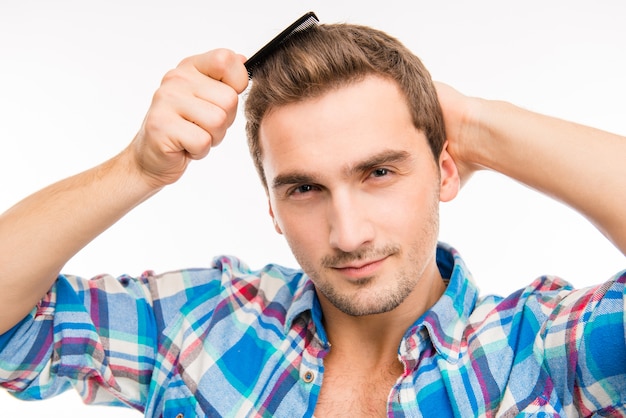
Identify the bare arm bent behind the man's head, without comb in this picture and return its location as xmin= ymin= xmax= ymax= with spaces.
xmin=437 ymin=84 xmax=626 ymax=254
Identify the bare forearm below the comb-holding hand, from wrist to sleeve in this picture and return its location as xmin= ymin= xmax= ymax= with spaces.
xmin=0 ymin=149 xmax=156 ymax=333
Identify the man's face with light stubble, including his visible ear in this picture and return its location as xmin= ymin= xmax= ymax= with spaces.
xmin=260 ymin=76 xmax=458 ymax=316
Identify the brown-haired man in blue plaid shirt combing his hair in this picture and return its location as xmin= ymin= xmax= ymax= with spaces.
xmin=0 ymin=25 xmax=626 ymax=416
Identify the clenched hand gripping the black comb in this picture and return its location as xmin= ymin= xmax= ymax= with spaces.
xmin=127 ymin=49 xmax=248 ymax=188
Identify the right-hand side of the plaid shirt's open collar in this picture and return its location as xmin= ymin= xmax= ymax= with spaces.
xmin=399 ymin=243 xmax=478 ymax=363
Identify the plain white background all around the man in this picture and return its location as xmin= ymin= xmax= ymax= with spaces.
xmin=0 ymin=0 xmax=626 ymax=417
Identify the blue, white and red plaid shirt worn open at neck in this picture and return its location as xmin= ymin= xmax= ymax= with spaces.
xmin=0 ymin=245 xmax=626 ymax=417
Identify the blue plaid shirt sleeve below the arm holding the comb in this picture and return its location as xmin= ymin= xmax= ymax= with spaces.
xmin=0 ymin=269 xmax=213 ymax=410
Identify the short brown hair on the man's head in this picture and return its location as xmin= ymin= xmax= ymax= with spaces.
xmin=245 ymin=24 xmax=445 ymax=188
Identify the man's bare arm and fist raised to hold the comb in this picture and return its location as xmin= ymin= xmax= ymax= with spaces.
xmin=0 ymin=50 xmax=248 ymax=334
